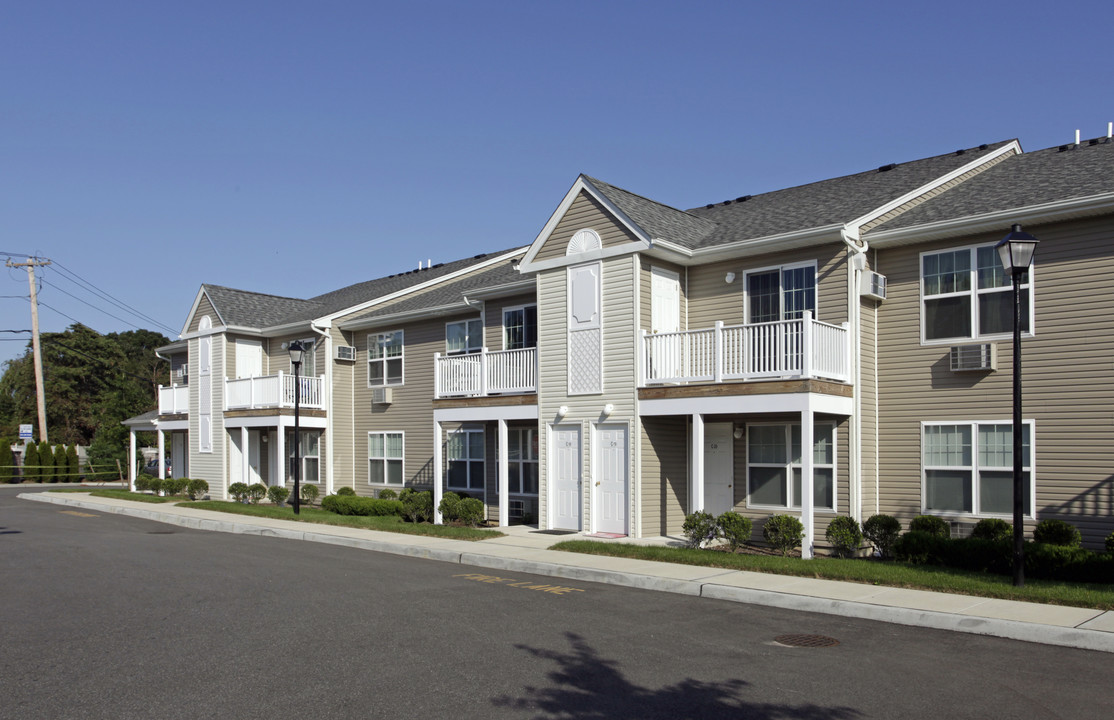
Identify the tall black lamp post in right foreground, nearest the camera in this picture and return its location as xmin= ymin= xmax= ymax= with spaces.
xmin=996 ymin=225 xmax=1037 ymax=587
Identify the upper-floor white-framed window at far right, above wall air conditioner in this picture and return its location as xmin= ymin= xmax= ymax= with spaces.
xmin=920 ymin=245 xmax=1033 ymax=341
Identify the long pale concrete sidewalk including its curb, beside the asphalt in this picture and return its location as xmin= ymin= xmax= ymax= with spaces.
xmin=19 ymin=493 xmax=1114 ymax=652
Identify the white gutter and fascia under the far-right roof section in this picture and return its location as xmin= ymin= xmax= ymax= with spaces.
xmin=868 ymin=193 xmax=1114 ymax=247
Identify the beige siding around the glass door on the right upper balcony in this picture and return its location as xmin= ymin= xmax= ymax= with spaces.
xmin=686 ymin=243 xmax=848 ymax=330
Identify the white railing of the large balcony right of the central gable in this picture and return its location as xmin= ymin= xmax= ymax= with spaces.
xmin=642 ymin=312 xmax=851 ymax=386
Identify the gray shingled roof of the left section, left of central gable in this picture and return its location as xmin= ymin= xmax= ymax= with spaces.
xmin=202 ymin=249 xmax=525 ymax=328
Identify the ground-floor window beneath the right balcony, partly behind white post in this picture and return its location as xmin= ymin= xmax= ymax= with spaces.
xmin=746 ymin=422 xmax=836 ymax=510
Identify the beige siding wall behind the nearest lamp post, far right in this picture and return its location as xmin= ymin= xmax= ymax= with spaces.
xmin=878 ymin=218 xmax=1114 ymax=546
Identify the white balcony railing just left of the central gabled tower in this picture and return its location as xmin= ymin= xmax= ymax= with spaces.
xmin=433 ymin=348 xmax=538 ymax=398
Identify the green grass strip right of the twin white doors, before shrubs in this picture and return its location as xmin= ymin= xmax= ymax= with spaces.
xmin=553 ymin=541 xmax=1114 ymax=610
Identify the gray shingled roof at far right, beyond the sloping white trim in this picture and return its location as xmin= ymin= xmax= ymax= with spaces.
xmin=871 ymin=137 xmax=1114 ymax=232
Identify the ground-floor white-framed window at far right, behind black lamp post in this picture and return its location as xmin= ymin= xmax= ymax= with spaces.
xmin=921 ymin=420 xmax=1034 ymax=517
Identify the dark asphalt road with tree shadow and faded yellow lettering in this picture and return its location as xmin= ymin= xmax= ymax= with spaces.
xmin=0 ymin=488 xmax=1114 ymax=720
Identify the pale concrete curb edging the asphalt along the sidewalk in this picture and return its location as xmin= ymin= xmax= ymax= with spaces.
xmin=26 ymin=493 xmax=1114 ymax=653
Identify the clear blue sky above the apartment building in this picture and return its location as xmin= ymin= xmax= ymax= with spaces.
xmin=0 ymin=0 xmax=1114 ymax=367
